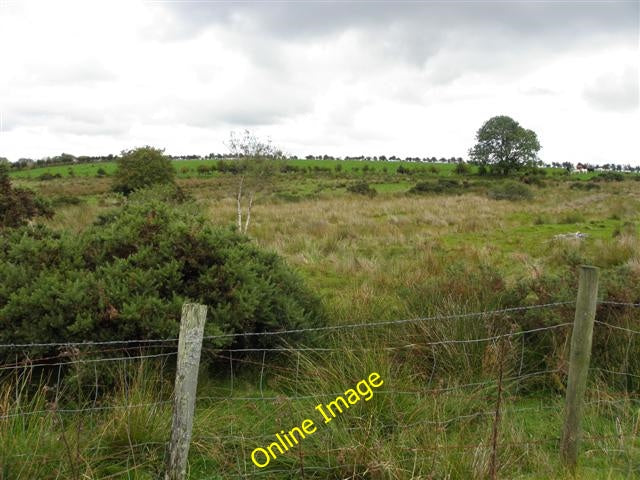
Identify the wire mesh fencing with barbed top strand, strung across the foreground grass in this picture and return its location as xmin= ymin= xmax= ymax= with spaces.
xmin=0 ymin=301 xmax=640 ymax=480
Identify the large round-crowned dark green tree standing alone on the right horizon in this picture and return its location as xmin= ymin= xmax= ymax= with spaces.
xmin=469 ymin=115 xmax=540 ymax=175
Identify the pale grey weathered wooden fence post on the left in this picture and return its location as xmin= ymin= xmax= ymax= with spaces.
xmin=165 ymin=303 xmax=207 ymax=480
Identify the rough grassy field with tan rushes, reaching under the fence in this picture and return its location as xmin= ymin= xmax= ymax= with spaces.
xmin=0 ymin=160 xmax=640 ymax=480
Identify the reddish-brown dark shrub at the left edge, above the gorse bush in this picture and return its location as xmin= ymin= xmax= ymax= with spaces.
xmin=0 ymin=164 xmax=53 ymax=231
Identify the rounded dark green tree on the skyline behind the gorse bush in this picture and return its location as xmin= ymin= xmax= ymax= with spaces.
xmin=113 ymin=146 xmax=176 ymax=195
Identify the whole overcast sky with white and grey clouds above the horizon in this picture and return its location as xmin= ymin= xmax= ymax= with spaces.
xmin=0 ymin=0 xmax=640 ymax=165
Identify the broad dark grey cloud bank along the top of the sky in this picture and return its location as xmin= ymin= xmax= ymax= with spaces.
xmin=157 ymin=1 xmax=638 ymax=85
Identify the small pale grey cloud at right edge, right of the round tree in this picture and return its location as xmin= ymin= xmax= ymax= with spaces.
xmin=583 ymin=67 xmax=640 ymax=112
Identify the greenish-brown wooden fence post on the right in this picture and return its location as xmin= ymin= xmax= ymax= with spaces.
xmin=560 ymin=265 xmax=598 ymax=470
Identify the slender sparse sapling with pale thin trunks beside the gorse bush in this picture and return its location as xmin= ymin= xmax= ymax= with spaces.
xmin=227 ymin=130 xmax=283 ymax=235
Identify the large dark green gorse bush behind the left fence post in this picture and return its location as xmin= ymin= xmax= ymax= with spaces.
xmin=0 ymin=192 xmax=324 ymax=364
